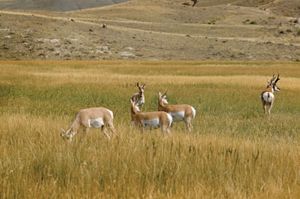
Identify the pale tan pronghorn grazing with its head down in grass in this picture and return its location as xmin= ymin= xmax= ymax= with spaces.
xmin=61 ymin=107 xmax=115 ymax=140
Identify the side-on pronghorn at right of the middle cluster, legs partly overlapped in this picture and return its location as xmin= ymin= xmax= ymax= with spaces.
xmin=158 ymin=92 xmax=196 ymax=131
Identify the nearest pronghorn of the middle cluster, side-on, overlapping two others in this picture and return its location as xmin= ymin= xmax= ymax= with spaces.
xmin=130 ymin=99 xmax=173 ymax=134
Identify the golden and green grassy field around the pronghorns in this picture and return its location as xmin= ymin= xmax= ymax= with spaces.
xmin=0 ymin=61 xmax=300 ymax=198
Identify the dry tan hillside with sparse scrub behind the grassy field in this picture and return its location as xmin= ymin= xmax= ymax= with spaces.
xmin=0 ymin=0 xmax=300 ymax=61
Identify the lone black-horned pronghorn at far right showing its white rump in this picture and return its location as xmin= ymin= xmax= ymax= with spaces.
xmin=260 ymin=74 xmax=280 ymax=114
